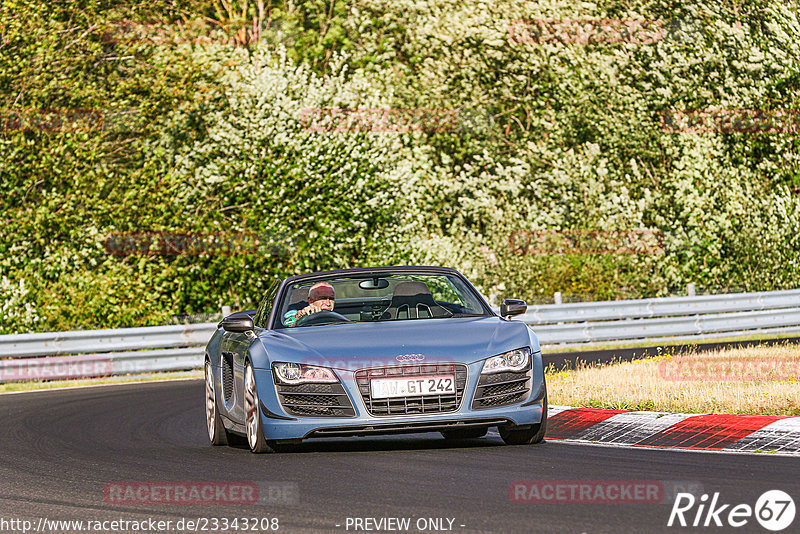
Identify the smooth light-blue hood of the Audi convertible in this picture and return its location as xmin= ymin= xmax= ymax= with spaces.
xmin=261 ymin=317 xmax=539 ymax=370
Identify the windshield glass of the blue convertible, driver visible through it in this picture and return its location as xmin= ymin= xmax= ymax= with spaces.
xmin=275 ymin=273 xmax=490 ymax=328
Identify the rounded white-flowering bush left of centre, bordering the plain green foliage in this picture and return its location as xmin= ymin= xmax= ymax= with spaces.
xmin=175 ymin=47 xmax=432 ymax=286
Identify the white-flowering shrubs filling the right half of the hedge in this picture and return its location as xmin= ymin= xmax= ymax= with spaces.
xmin=340 ymin=0 xmax=800 ymax=298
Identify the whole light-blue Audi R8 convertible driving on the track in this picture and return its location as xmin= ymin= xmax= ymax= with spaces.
xmin=205 ymin=267 xmax=547 ymax=453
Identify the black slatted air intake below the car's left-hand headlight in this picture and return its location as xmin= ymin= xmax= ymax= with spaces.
xmin=275 ymin=383 xmax=356 ymax=417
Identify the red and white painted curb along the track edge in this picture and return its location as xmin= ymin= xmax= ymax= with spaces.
xmin=494 ymin=406 xmax=800 ymax=456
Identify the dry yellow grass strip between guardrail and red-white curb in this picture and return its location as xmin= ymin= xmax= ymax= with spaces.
xmin=547 ymin=345 xmax=800 ymax=416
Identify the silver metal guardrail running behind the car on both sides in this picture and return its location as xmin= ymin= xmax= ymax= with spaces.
xmin=0 ymin=290 xmax=800 ymax=383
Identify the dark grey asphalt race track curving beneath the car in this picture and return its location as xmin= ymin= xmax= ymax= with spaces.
xmin=0 ymin=380 xmax=800 ymax=534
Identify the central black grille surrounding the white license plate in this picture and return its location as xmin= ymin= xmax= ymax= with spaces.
xmin=355 ymin=363 xmax=467 ymax=415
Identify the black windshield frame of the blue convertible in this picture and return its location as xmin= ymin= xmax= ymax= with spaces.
xmin=267 ymin=266 xmax=497 ymax=332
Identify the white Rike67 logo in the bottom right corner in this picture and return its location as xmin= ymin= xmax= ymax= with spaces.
xmin=667 ymin=490 xmax=796 ymax=532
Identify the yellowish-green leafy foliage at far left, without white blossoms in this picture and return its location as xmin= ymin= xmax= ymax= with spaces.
xmin=0 ymin=1 xmax=232 ymax=331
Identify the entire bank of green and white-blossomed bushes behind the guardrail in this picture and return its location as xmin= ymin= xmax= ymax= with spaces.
xmin=0 ymin=0 xmax=800 ymax=332
